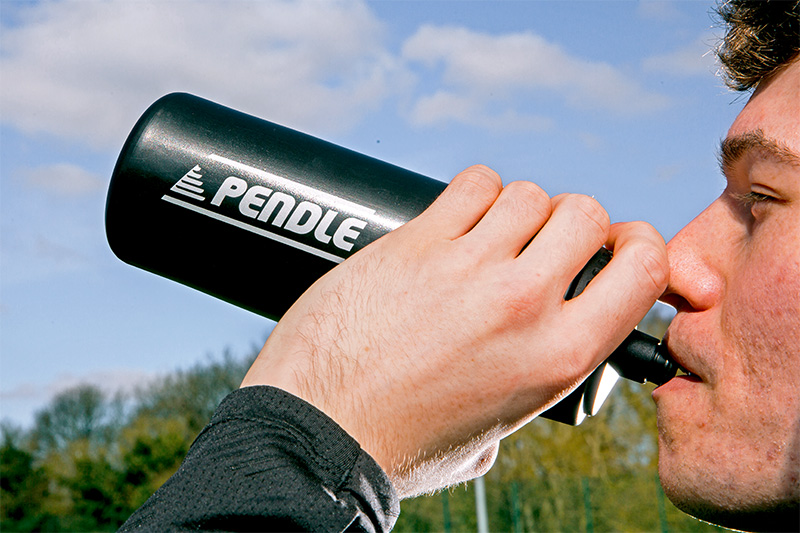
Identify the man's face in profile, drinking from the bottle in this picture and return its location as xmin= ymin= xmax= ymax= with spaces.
xmin=653 ymin=60 xmax=800 ymax=530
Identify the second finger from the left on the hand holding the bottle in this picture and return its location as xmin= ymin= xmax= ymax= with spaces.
xmin=462 ymin=181 xmax=552 ymax=259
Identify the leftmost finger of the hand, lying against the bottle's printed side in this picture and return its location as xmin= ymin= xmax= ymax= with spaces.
xmin=406 ymin=165 xmax=503 ymax=239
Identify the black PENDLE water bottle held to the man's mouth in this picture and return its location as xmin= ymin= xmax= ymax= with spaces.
xmin=106 ymin=93 xmax=675 ymax=424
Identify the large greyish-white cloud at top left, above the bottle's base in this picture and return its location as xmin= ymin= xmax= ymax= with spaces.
xmin=0 ymin=0 xmax=402 ymax=147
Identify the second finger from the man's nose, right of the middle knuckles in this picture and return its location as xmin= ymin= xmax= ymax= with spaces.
xmin=520 ymin=194 xmax=610 ymax=288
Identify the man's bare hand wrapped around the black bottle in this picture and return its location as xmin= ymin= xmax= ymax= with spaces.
xmin=242 ymin=166 xmax=668 ymax=497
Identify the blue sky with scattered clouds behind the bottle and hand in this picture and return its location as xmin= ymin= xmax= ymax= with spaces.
xmin=0 ymin=0 xmax=745 ymax=424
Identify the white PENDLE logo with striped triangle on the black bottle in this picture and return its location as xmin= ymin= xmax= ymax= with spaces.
xmin=161 ymin=154 xmax=375 ymax=263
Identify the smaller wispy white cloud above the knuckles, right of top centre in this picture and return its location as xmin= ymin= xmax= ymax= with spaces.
xmin=402 ymin=25 xmax=669 ymax=128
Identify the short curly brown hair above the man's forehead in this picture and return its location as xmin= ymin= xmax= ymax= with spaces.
xmin=717 ymin=0 xmax=800 ymax=91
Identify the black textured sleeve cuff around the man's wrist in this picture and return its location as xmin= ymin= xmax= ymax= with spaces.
xmin=120 ymin=387 xmax=400 ymax=531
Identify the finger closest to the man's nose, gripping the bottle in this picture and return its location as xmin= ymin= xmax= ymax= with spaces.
xmin=564 ymin=222 xmax=669 ymax=365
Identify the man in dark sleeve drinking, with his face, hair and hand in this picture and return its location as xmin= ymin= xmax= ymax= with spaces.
xmin=123 ymin=1 xmax=800 ymax=530
